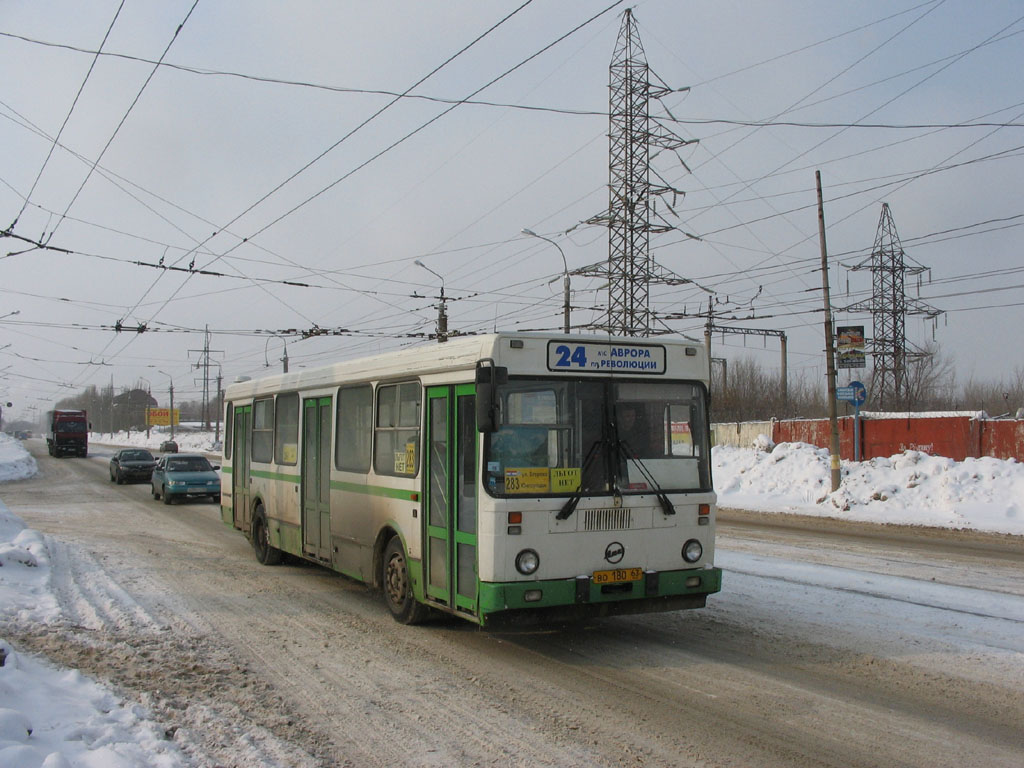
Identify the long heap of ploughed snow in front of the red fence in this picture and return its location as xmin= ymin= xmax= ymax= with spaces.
xmin=712 ymin=442 xmax=1024 ymax=536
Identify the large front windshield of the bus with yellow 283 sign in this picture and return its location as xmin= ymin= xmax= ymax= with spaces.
xmin=483 ymin=378 xmax=711 ymax=496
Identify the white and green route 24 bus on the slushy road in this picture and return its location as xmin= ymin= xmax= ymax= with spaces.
xmin=221 ymin=333 xmax=722 ymax=627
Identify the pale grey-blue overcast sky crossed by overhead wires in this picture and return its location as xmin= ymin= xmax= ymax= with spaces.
xmin=0 ymin=0 xmax=1024 ymax=417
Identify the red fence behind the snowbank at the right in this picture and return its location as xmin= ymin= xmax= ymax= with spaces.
xmin=772 ymin=414 xmax=1024 ymax=461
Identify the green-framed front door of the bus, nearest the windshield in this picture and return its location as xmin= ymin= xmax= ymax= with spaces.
xmin=423 ymin=384 xmax=478 ymax=614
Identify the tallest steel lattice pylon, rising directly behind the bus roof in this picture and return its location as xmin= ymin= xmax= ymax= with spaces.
xmin=579 ymin=9 xmax=693 ymax=336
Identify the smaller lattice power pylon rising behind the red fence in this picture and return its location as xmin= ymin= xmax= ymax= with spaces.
xmin=848 ymin=203 xmax=941 ymax=410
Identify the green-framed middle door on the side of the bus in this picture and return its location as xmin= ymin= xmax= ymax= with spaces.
xmin=301 ymin=397 xmax=331 ymax=562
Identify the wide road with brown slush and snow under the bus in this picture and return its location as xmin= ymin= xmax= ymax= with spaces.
xmin=0 ymin=444 xmax=1024 ymax=768
